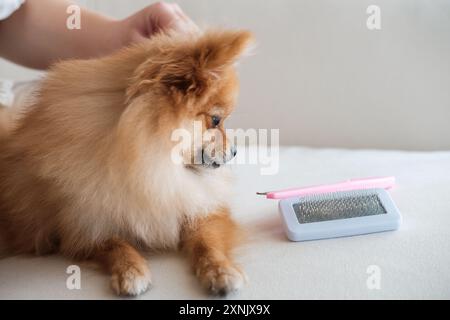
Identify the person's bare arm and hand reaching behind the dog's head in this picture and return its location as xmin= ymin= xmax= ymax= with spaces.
xmin=0 ymin=0 xmax=194 ymax=69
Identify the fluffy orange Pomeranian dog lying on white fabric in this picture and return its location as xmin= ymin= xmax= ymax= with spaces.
xmin=0 ymin=30 xmax=252 ymax=295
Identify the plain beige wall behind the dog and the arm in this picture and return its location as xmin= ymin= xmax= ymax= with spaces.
xmin=0 ymin=0 xmax=450 ymax=150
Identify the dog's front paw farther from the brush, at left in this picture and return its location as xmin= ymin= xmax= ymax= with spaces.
xmin=111 ymin=266 xmax=152 ymax=296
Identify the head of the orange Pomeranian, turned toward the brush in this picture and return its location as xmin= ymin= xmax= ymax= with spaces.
xmin=127 ymin=31 xmax=252 ymax=168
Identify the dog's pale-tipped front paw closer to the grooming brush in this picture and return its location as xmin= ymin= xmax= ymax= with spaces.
xmin=197 ymin=264 xmax=247 ymax=296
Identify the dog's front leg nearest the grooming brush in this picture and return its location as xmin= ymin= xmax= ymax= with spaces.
xmin=182 ymin=209 xmax=246 ymax=295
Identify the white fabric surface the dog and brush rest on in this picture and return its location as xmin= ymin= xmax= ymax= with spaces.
xmin=0 ymin=147 xmax=450 ymax=299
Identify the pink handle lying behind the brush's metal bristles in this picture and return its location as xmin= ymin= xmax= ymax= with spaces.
xmin=266 ymin=177 xmax=395 ymax=199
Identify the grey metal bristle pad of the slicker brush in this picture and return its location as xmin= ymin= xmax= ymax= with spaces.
xmin=294 ymin=190 xmax=386 ymax=223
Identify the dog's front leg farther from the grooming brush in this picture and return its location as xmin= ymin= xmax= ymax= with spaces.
xmin=93 ymin=239 xmax=151 ymax=296
